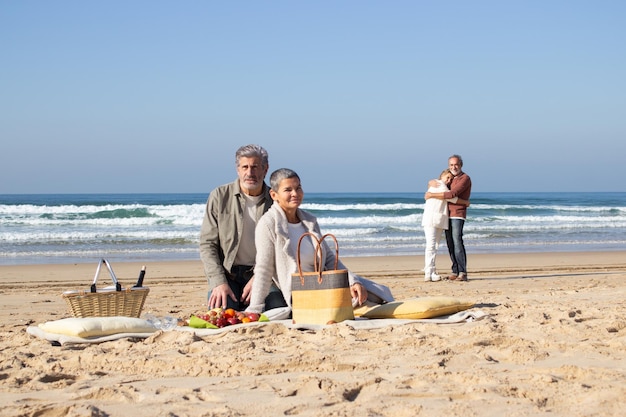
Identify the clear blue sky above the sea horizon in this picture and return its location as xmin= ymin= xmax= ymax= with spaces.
xmin=0 ymin=0 xmax=626 ymax=194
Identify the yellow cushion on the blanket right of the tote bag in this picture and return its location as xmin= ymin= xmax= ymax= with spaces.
xmin=355 ymin=296 xmax=474 ymax=319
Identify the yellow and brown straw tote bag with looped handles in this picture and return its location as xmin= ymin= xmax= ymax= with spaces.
xmin=291 ymin=232 xmax=354 ymax=324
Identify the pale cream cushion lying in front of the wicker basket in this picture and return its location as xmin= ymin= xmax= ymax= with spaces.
xmin=39 ymin=317 xmax=157 ymax=337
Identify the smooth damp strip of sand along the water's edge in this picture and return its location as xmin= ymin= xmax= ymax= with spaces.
xmin=0 ymin=251 xmax=626 ymax=286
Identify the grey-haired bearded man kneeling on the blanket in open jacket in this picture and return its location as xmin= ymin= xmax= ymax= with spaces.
xmin=200 ymin=144 xmax=286 ymax=311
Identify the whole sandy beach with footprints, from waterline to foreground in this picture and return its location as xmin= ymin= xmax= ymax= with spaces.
xmin=0 ymin=252 xmax=626 ymax=417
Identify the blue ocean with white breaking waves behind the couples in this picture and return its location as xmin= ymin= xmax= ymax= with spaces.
xmin=0 ymin=192 xmax=626 ymax=265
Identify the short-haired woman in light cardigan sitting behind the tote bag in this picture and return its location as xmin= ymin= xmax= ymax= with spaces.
xmin=246 ymin=168 xmax=368 ymax=313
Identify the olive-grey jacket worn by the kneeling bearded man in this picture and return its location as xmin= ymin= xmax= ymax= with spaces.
xmin=200 ymin=179 xmax=273 ymax=290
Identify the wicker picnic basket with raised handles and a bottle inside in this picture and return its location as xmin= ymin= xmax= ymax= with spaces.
xmin=63 ymin=259 xmax=150 ymax=317
